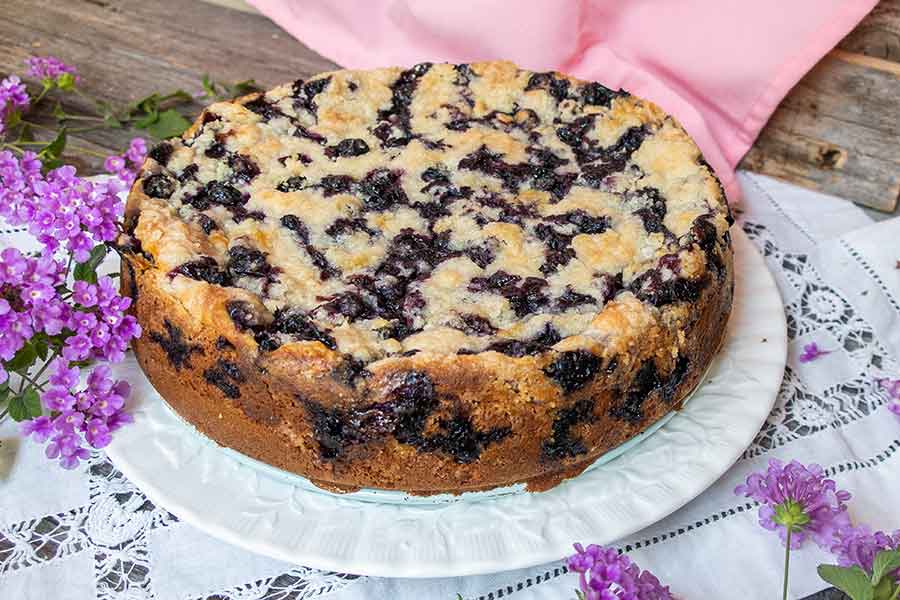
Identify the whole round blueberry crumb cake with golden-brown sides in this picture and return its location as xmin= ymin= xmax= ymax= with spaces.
xmin=120 ymin=62 xmax=733 ymax=494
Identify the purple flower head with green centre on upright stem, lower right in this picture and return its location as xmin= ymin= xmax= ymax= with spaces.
xmin=734 ymin=458 xmax=850 ymax=548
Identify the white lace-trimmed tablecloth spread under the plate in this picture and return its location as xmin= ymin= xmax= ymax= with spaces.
xmin=0 ymin=174 xmax=900 ymax=600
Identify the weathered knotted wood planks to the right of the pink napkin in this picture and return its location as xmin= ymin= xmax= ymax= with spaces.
xmin=741 ymin=0 xmax=900 ymax=212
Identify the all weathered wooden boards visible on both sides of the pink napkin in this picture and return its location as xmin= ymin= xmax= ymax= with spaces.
xmin=0 ymin=0 xmax=900 ymax=212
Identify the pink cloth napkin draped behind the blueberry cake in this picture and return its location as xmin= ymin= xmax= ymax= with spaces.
xmin=249 ymin=0 xmax=877 ymax=199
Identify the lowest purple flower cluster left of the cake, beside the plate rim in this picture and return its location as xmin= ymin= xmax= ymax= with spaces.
xmin=20 ymin=358 xmax=132 ymax=469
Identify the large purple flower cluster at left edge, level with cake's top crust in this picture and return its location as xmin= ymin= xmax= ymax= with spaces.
xmin=0 ymin=151 xmax=129 ymax=262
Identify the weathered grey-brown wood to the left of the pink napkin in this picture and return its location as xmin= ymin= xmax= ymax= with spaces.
xmin=0 ymin=0 xmax=335 ymax=172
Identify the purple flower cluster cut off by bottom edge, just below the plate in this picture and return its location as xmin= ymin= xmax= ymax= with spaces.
xmin=566 ymin=544 xmax=672 ymax=600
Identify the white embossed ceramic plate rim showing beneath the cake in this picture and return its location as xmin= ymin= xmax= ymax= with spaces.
xmin=107 ymin=228 xmax=787 ymax=577
